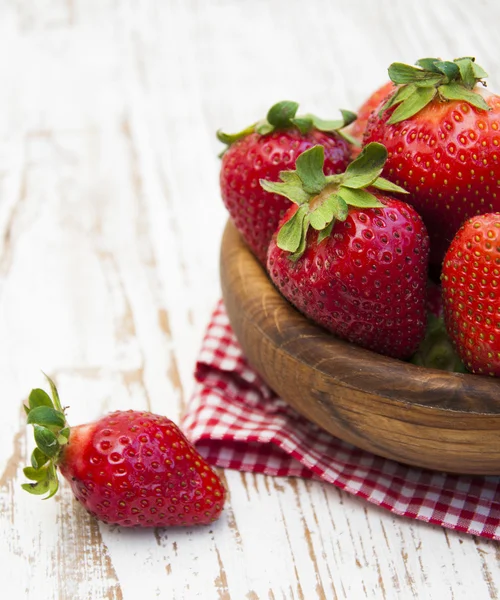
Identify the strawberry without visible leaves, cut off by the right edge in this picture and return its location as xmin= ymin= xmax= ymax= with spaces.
xmin=442 ymin=213 xmax=500 ymax=377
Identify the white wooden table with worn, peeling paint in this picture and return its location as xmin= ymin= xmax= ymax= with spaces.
xmin=0 ymin=0 xmax=500 ymax=600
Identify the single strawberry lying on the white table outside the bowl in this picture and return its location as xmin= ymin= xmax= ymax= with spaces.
xmin=23 ymin=379 xmax=225 ymax=527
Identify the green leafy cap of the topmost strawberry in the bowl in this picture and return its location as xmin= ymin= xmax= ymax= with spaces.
xmin=379 ymin=56 xmax=491 ymax=125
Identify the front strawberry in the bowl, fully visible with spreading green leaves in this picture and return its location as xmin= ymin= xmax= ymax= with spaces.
xmin=262 ymin=144 xmax=429 ymax=359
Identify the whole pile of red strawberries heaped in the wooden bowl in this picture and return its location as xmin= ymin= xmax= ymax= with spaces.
xmin=218 ymin=57 xmax=500 ymax=376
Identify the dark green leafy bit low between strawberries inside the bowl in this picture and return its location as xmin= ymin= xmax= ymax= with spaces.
xmin=410 ymin=313 xmax=467 ymax=373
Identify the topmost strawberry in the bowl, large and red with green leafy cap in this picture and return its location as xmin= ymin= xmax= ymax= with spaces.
xmin=364 ymin=58 xmax=500 ymax=271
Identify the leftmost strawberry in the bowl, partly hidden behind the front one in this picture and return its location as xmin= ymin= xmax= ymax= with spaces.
xmin=217 ymin=101 xmax=356 ymax=264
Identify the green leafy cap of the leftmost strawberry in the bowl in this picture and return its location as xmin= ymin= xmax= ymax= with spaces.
xmin=217 ymin=100 xmax=359 ymax=147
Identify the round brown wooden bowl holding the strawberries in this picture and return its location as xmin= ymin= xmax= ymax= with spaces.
xmin=221 ymin=223 xmax=500 ymax=475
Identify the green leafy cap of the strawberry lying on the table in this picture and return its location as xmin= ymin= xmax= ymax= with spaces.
xmin=22 ymin=375 xmax=70 ymax=499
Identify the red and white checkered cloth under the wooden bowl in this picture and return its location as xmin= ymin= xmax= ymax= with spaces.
xmin=182 ymin=302 xmax=500 ymax=540
